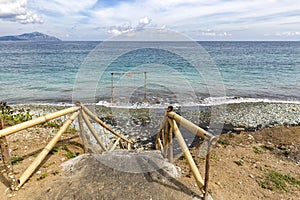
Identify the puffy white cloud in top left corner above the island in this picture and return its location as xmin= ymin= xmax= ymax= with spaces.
xmin=0 ymin=0 xmax=43 ymax=24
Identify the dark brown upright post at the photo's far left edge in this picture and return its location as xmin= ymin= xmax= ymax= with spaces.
xmin=0 ymin=119 xmax=17 ymax=190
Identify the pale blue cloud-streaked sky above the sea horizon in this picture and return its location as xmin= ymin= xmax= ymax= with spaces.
xmin=0 ymin=0 xmax=300 ymax=41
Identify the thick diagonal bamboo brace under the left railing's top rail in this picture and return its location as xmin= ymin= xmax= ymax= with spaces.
xmin=17 ymin=112 xmax=79 ymax=189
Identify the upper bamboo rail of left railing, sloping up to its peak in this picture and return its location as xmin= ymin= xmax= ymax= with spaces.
xmin=0 ymin=107 xmax=80 ymax=137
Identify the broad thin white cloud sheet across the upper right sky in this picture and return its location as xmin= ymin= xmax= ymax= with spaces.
xmin=93 ymin=0 xmax=300 ymax=35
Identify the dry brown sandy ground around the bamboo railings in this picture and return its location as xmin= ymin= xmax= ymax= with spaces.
xmin=0 ymin=127 xmax=300 ymax=200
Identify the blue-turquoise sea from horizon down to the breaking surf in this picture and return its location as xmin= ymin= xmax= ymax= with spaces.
xmin=0 ymin=41 xmax=300 ymax=107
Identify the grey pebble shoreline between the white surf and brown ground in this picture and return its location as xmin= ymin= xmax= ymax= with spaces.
xmin=11 ymin=102 xmax=300 ymax=134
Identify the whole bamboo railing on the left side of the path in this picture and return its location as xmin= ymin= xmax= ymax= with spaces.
xmin=0 ymin=103 xmax=132 ymax=190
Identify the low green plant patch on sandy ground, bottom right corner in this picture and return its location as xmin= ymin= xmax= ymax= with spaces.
xmin=259 ymin=171 xmax=300 ymax=192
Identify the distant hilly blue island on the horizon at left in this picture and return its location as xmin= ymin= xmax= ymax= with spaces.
xmin=0 ymin=32 xmax=61 ymax=42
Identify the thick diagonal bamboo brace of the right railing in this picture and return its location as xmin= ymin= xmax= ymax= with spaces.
xmin=168 ymin=119 xmax=204 ymax=193
